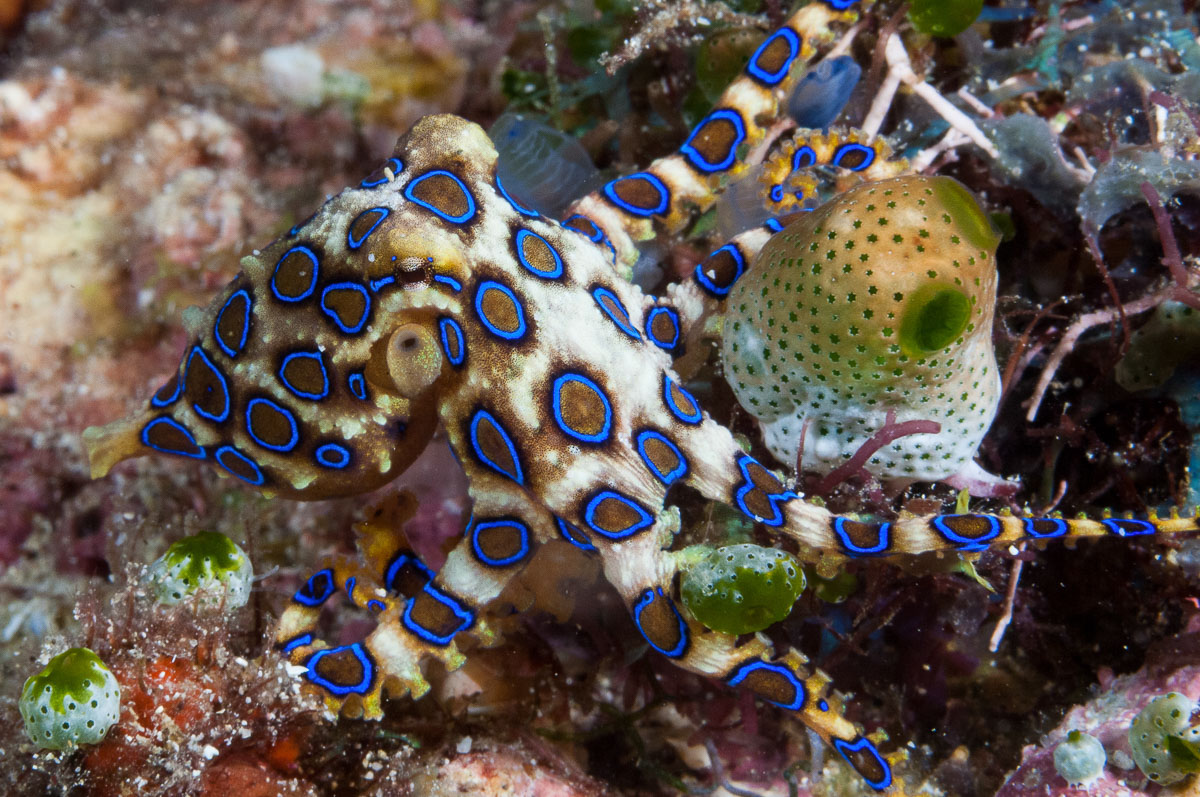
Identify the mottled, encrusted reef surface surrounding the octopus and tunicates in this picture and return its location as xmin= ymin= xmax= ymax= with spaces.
xmin=0 ymin=0 xmax=1200 ymax=797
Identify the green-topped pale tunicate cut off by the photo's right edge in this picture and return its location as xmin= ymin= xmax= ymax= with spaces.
xmin=1129 ymin=691 xmax=1200 ymax=786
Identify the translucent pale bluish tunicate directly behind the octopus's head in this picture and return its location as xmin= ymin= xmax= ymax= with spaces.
xmin=487 ymin=113 xmax=600 ymax=217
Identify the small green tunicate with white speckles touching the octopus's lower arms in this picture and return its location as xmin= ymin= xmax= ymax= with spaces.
xmin=680 ymin=543 xmax=804 ymax=635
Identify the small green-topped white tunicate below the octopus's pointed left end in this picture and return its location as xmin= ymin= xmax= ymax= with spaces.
xmin=146 ymin=532 xmax=254 ymax=609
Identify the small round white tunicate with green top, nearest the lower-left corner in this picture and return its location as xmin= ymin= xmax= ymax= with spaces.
xmin=19 ymin=648 xmax=121 ymax=750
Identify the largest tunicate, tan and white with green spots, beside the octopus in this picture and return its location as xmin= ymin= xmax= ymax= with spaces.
xmin=722 ymin=176 xmax=1001 ymax=481
